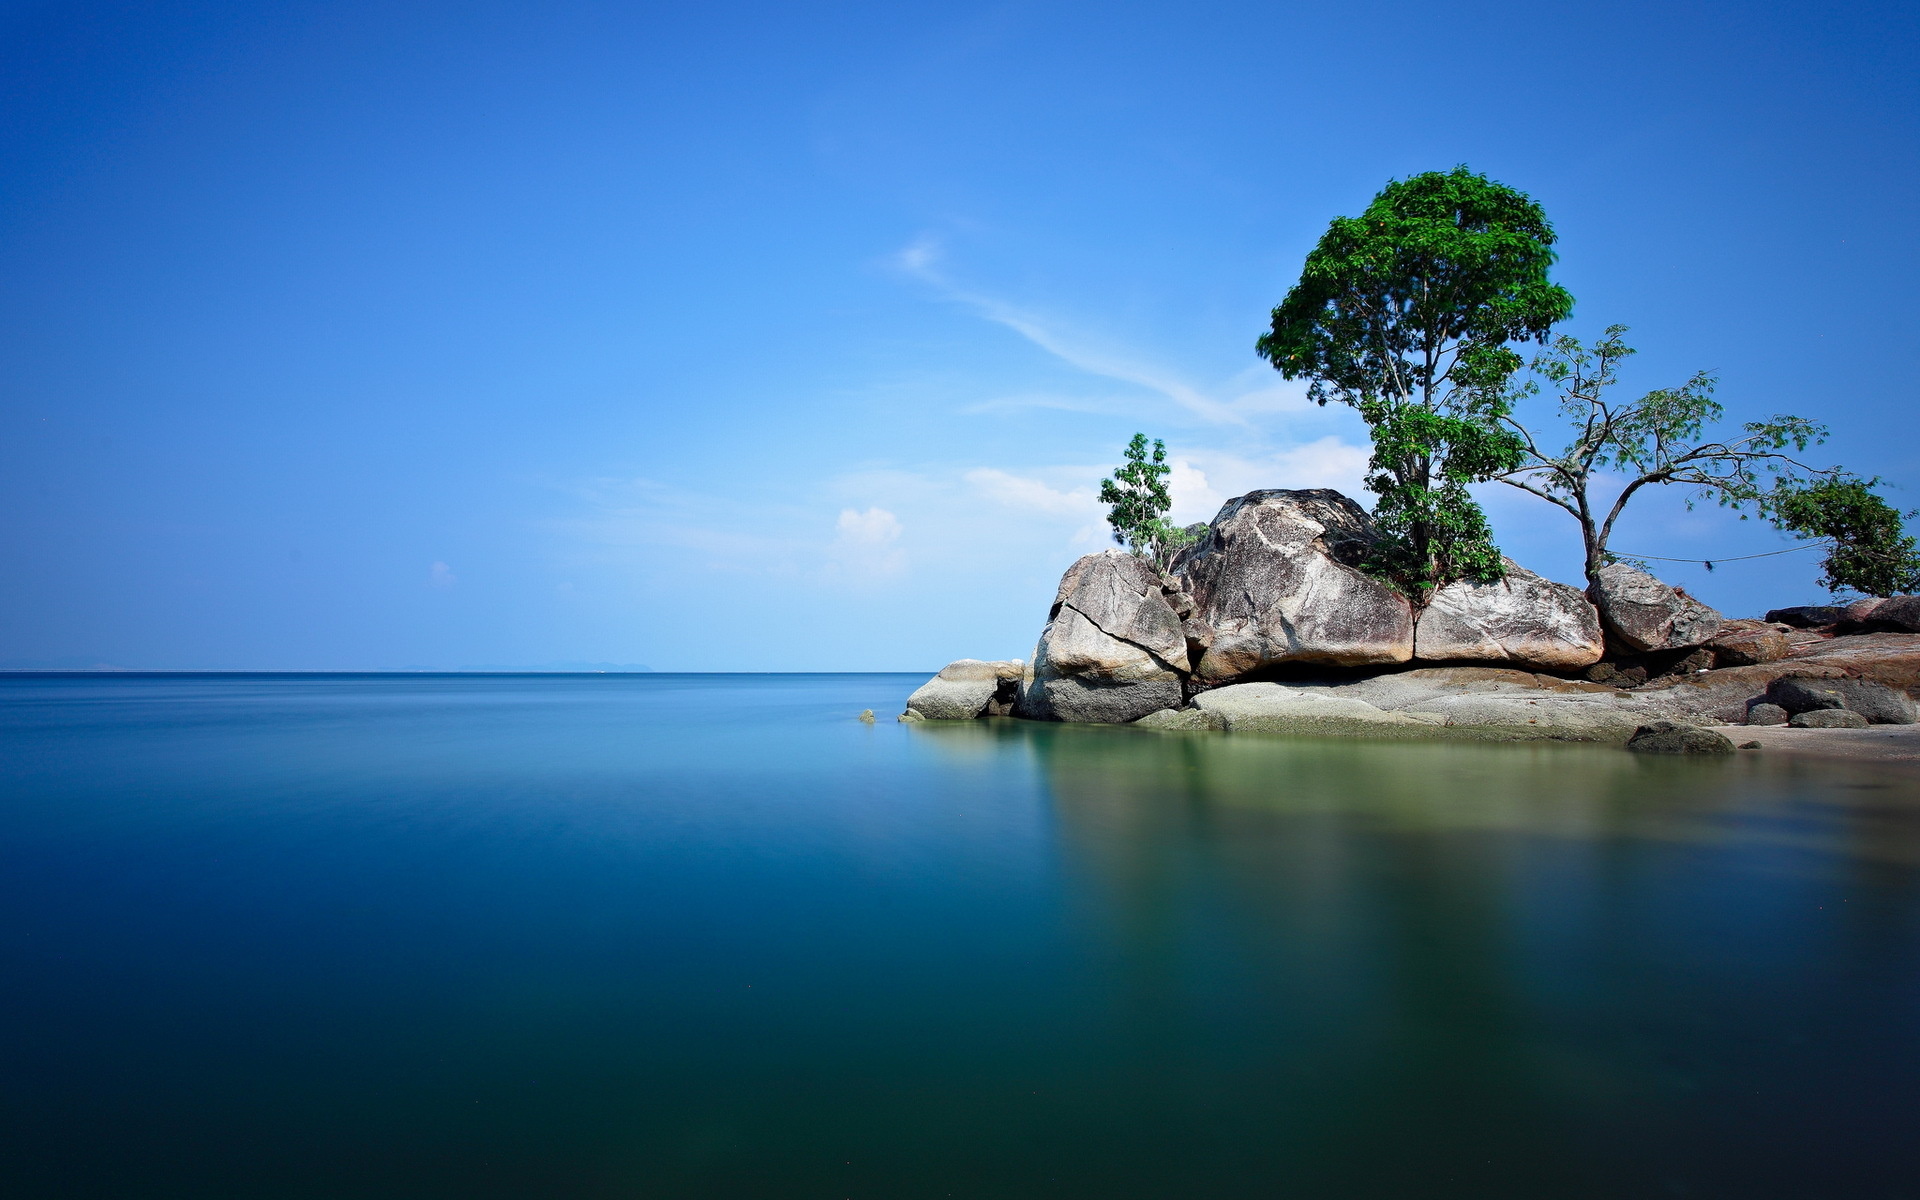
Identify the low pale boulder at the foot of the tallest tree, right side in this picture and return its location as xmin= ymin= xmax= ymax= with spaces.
xmin=1413 ymin=559 xmax=1607 ymax=670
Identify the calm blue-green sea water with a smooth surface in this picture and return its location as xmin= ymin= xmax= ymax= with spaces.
xmin=0 ymin=676 xmax=1920 ymax=1200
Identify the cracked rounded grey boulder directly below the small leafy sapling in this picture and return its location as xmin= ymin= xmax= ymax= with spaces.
xmin=1016 ymin=549 xmax=1188 ymax=724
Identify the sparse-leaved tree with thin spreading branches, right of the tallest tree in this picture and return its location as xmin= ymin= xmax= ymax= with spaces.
xmin=1494 ymin=324 xmax=1834 ymax=582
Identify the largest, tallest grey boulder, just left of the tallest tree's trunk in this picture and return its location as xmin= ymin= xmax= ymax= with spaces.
xmin=1175 ymin=488 xmax=1413 ymax=684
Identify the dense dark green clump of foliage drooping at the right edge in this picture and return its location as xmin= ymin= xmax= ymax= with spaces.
xmin=1764 ymin=472 xmax=1920 ymax=595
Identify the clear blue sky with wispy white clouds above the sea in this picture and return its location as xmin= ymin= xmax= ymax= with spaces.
xmin=0 ymin=0 xmax=1920 ymax=670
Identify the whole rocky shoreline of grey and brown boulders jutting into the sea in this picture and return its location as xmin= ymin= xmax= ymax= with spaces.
xmin=900 ymin=490 xmax=1920 ymax=751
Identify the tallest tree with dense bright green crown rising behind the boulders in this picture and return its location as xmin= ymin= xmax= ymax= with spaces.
xmin=1256 ymin=167 xmax=1572 ymax=593
